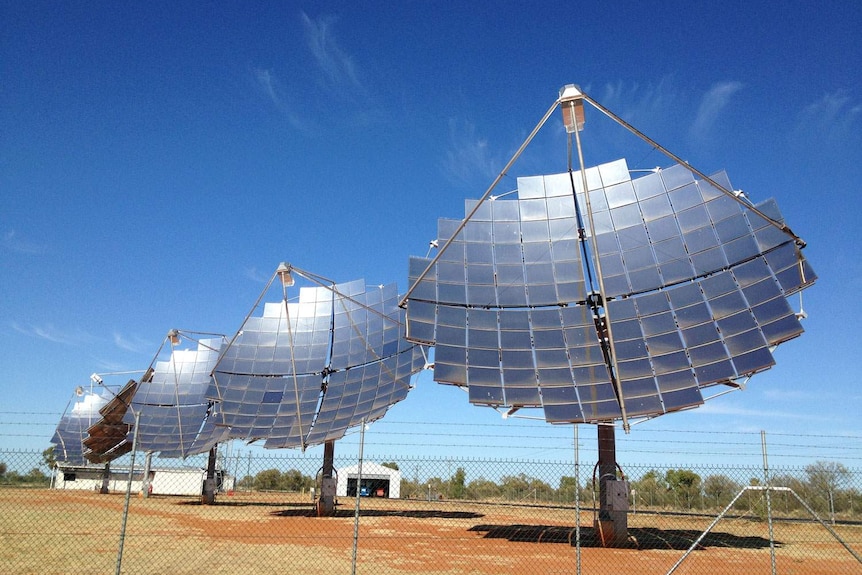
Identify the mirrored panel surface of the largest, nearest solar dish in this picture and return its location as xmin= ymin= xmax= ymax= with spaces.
xmin=406 ymin=156 xmax=815 ymax=423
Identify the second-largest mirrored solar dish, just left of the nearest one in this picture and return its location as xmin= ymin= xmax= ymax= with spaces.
xmin=207 ymin=264 xmax=426 ymax=449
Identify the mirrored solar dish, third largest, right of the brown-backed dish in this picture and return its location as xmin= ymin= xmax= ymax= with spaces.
xmin=123 ymin=330 xmax=228 ymax=458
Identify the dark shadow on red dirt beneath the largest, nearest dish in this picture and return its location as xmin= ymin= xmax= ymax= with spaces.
xmin=470 ymin=525 xmax=781 ymax=551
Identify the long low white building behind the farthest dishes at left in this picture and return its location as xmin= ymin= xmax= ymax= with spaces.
xmin=53 ymin=463 xmax=234 ymax=496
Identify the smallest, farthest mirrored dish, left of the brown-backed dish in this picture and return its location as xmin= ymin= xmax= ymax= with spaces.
xmin=51 ymin=387 xmax=114 ymax=465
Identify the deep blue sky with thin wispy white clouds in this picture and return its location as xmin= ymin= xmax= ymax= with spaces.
xmin=0 ymin=0 xmax=862 ymax=465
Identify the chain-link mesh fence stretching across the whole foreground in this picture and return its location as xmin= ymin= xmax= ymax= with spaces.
xmin=0 ymin=434 xmax=862 ymax=575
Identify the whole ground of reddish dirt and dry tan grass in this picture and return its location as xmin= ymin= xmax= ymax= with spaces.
xmin=0 ymin=489 xmax=862 ymax=575
